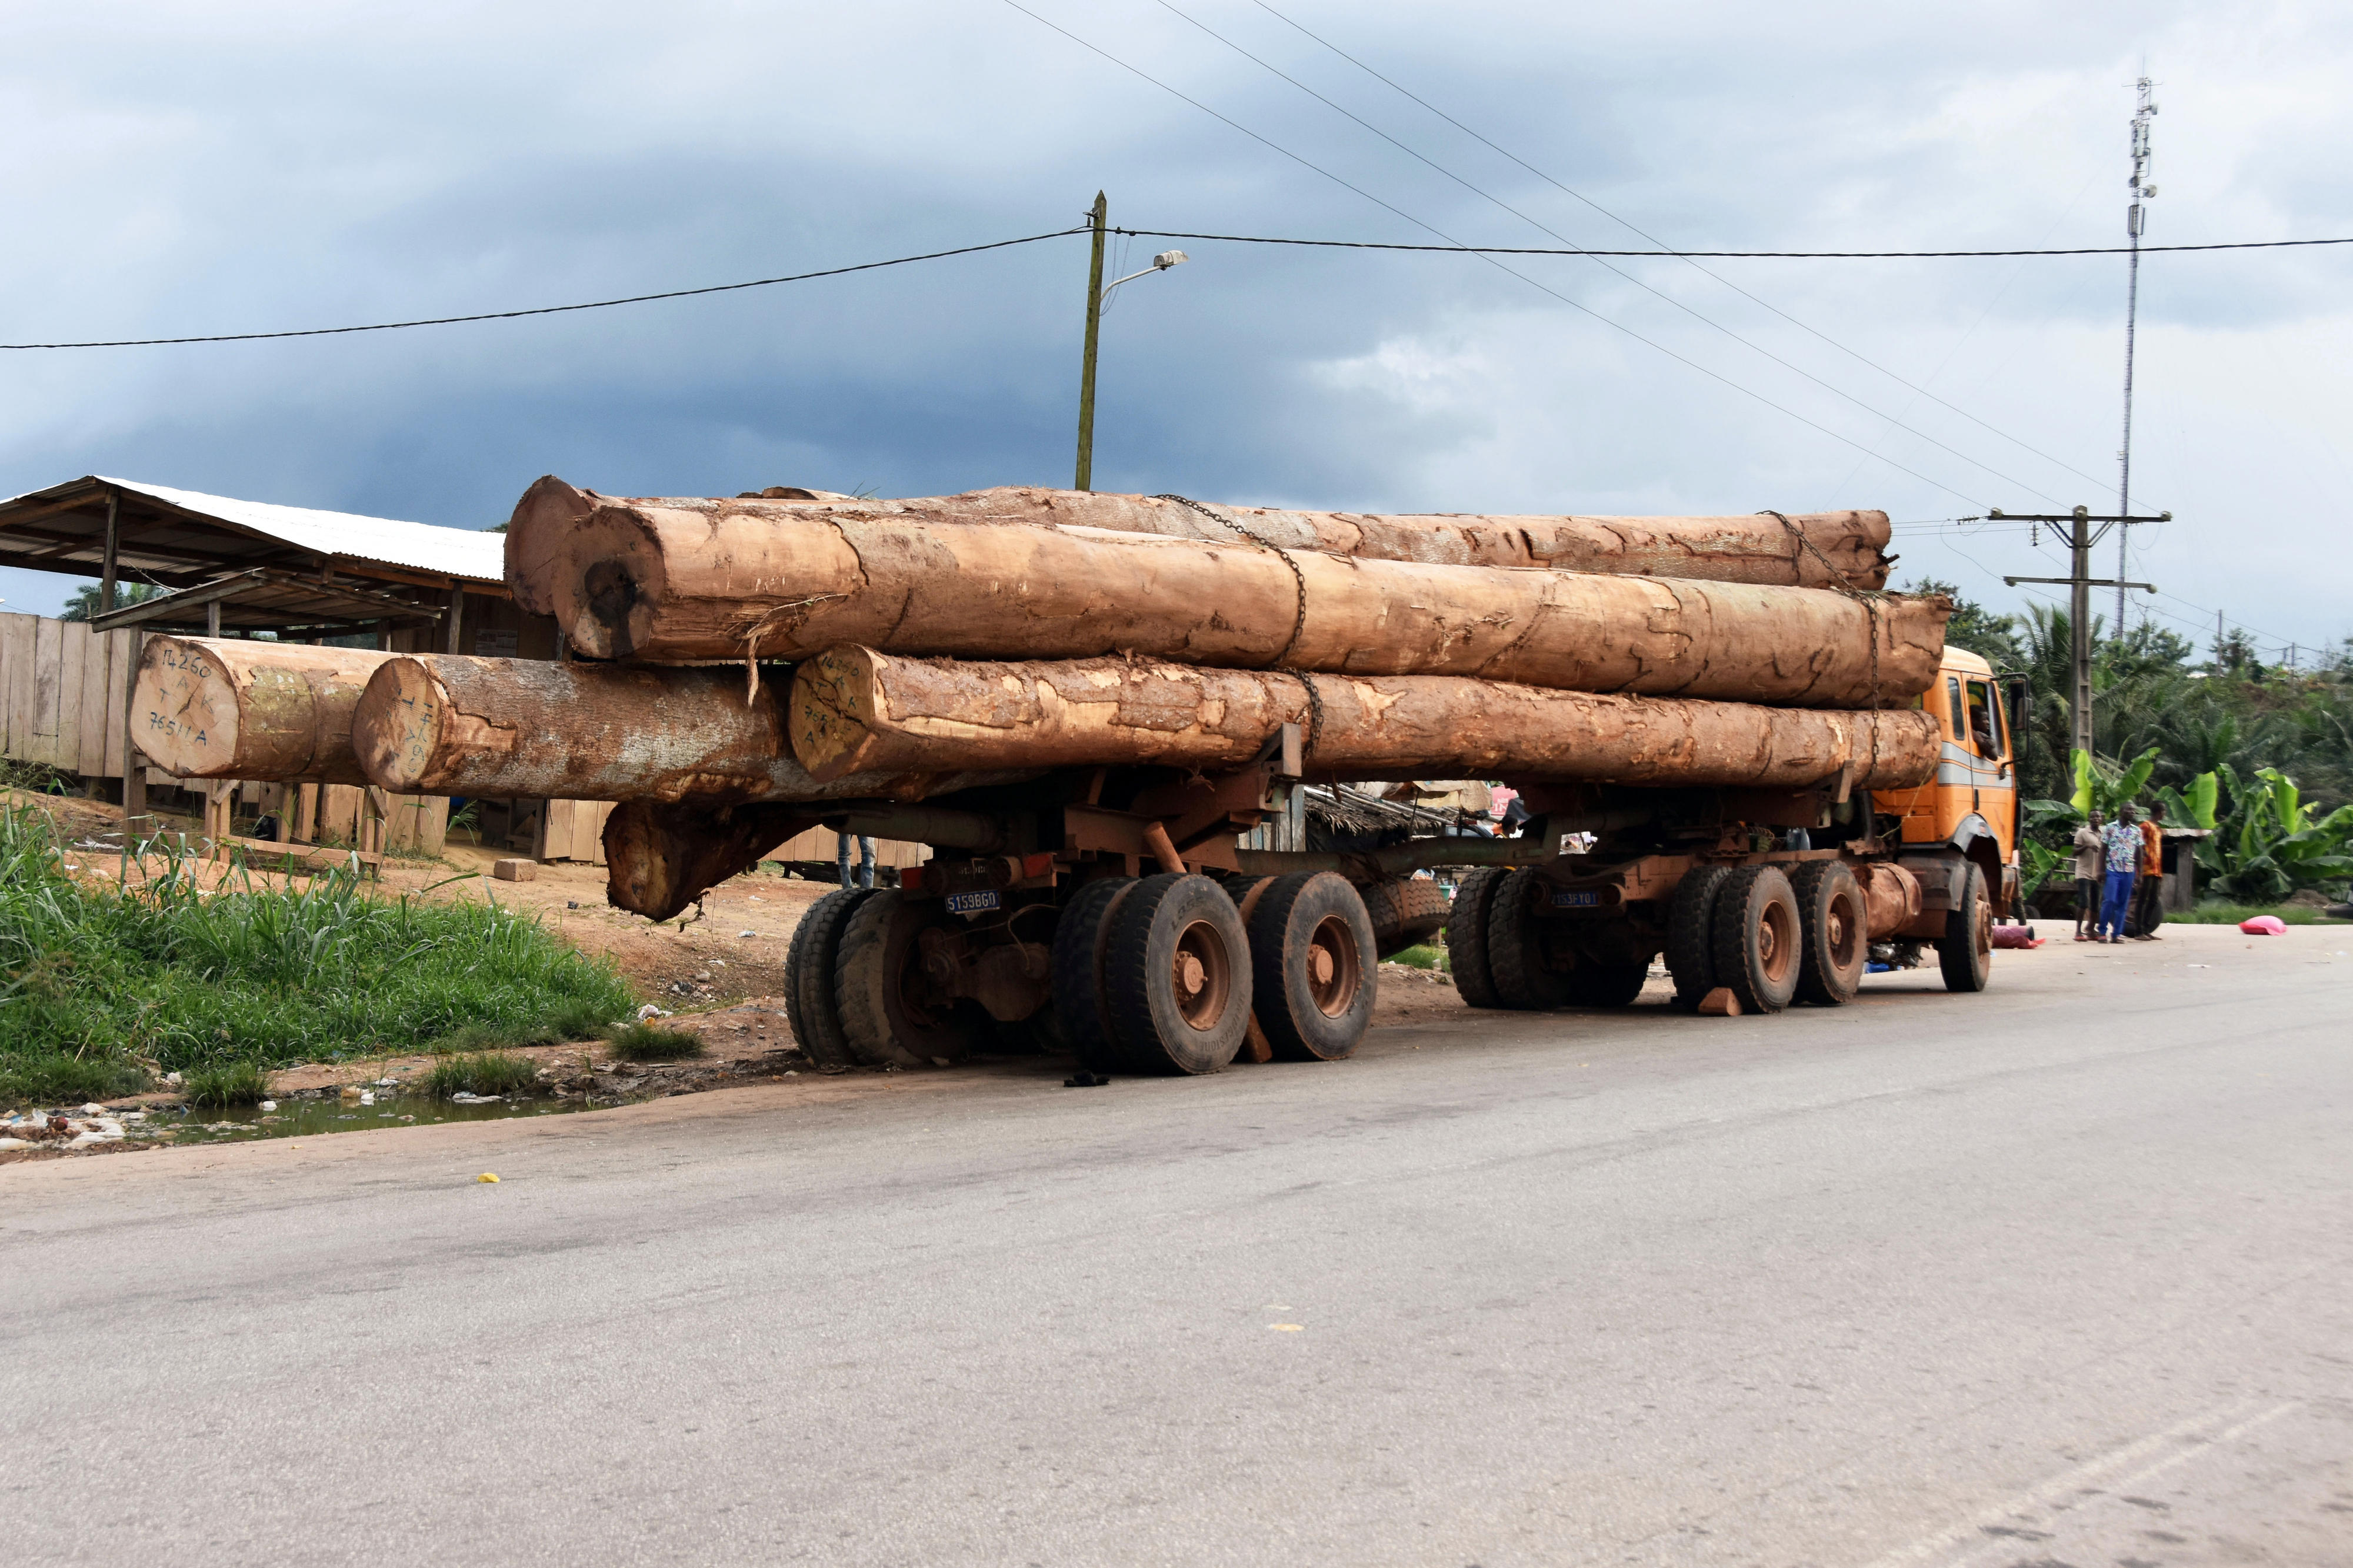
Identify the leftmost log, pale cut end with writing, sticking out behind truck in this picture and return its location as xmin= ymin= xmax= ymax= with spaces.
xmin=132 ymin=636 xmax=391 ymax=784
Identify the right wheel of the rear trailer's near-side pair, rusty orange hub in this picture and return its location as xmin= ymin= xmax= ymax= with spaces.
xmin=1249 ymin=871 xmax=1379 ymax=1062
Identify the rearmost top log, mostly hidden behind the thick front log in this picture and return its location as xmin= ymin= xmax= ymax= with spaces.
xmin=506 ymin=476 xmax=1894 ymax=598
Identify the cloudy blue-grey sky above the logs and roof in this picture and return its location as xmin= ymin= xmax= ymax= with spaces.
xmin=0 ymin=0 xmax=2353 ymax=650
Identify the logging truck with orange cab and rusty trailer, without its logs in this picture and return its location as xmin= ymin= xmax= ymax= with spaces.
xmin=786 ymin=650 xmax=2019 ymax=1073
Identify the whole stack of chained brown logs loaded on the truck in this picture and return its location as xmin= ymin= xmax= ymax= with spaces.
xmin=136 ymin=478 xmax=1951 ymax=918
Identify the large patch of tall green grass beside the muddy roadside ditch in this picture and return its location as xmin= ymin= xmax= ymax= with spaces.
xmin=0 ymin=808 xmax=635 ymax=1104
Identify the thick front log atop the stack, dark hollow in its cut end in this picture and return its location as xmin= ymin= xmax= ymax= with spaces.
xmin=508 ymin=481 xmax=1951 ymax=709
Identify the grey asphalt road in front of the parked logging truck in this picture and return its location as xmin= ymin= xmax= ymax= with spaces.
xmin=0 ymin=928 xmax=2353 ymax=1568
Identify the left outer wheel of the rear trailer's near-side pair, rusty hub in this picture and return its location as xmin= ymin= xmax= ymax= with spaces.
xmin=1104 ymin=871 xmax=1249 ymax=1073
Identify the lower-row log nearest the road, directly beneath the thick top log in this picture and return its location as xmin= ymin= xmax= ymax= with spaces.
xmin=791 ymin=648 xmax=1937 ymax=789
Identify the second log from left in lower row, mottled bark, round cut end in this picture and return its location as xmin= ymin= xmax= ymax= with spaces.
xmin=351 ymin=655 xmax=1031 ymax=803
